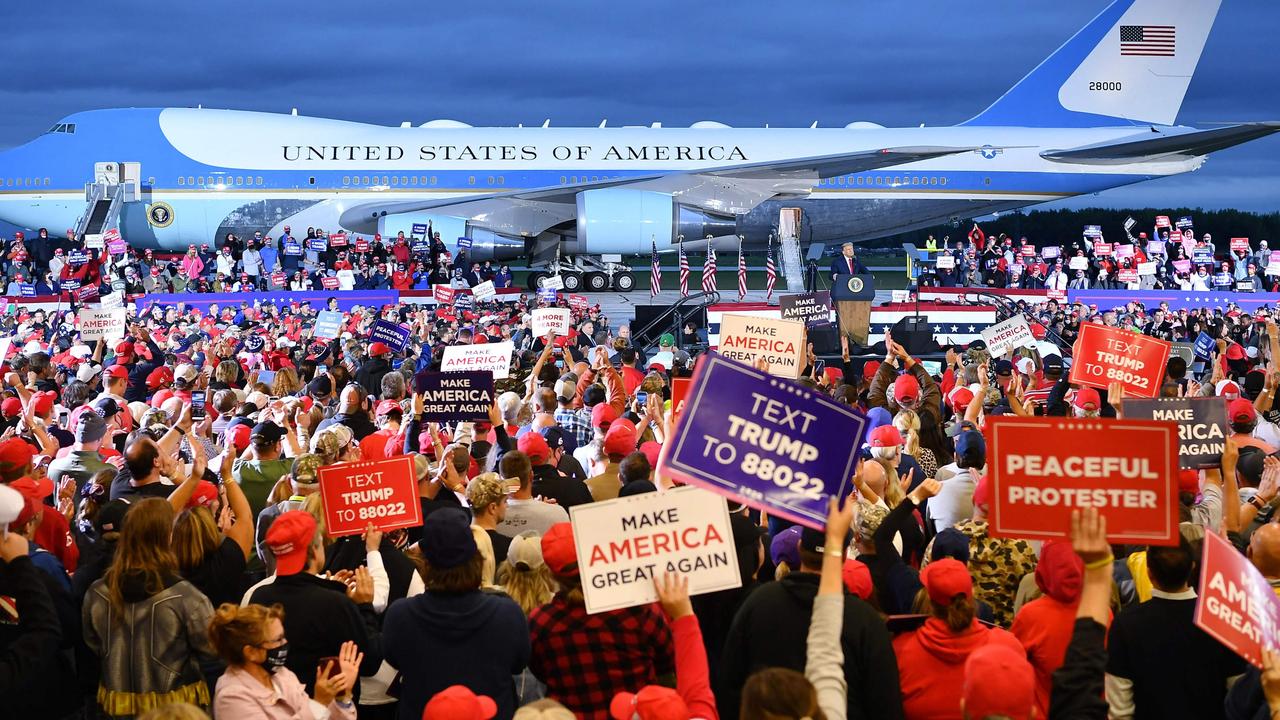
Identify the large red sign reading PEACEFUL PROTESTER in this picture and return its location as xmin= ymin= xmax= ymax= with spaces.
xmin=986 ymin=415 xmax=1178 ymax=544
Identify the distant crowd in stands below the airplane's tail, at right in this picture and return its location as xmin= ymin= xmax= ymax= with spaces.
xmin=920 ymin=219 xmax=1280 ymax=292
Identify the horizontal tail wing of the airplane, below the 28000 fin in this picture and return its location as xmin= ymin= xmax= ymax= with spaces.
xmin=1041 ymin=122 xmax=1280 ymax=165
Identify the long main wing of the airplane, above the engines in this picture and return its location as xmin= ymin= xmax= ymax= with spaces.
xmin=339 ymin=146 xmax=975 ymax=234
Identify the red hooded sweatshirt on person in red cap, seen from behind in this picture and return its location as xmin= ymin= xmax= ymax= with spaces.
xmin=893 ymin=618 xmax=1023 ymax=720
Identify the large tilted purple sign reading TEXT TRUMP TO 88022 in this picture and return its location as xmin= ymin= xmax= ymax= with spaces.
xmin=659 ymin=352 xmax=867 ymax=529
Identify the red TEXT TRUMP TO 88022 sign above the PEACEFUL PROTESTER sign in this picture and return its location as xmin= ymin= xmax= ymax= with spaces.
xmin=1070 ymin=323 xmax=1174 ymax=397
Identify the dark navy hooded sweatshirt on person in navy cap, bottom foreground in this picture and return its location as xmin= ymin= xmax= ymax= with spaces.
xmin=383 ymin=591 xmax=529 ymax=720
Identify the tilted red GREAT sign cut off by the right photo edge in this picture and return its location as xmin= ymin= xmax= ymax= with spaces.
xmin=1196 ymin=533 xmax=1280 ymax=667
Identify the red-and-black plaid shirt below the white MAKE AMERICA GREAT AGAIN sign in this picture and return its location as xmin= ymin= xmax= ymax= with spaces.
xmin=529 ymin=594 xmax=676 ymax=720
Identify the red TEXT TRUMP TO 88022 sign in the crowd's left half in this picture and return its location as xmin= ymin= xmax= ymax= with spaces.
xmin=319 ymin=455 xmax=422 ymax=537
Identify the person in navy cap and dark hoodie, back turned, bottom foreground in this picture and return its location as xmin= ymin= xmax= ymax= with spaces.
xmin=383 ymin=507 xmax=530 ymax=720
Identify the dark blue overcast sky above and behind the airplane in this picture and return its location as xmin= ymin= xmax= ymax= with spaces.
xmin=0 ymin=0 xmax=1280 ymax=211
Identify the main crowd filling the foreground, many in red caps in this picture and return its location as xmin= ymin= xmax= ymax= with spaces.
xmin=0 ymin=226 xmax=1280 ymax=720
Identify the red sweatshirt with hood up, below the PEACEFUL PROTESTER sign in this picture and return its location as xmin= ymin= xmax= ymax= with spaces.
xmin=1009 ymin=542 xmax=1084 ymax=717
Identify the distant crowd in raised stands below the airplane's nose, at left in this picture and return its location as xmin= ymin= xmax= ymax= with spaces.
xmin=0 ymin=225 xmax=512 ymax=299
